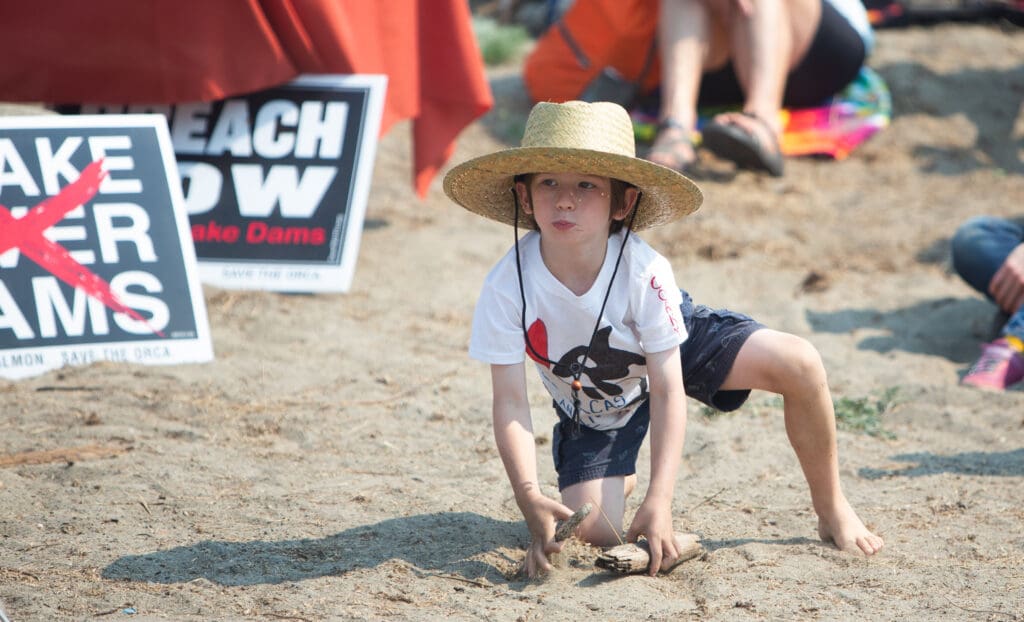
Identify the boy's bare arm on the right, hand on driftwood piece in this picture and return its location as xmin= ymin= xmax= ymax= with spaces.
xmin=627 ymin=347 xmax=686 ymax=576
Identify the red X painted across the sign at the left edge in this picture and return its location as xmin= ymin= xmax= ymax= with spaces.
xmin=0 ymin=160 xmax=163 ymax=336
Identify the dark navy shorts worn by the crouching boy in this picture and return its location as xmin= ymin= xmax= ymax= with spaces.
xmin=551 ymin=290 xmax=764 ymax=490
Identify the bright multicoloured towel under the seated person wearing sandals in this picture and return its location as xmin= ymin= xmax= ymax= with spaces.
xmin=632 ymin=67 xmax=892 ymax=160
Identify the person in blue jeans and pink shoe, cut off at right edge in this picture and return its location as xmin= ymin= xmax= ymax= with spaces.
xmin=952 ymin=216 xmax=1024 ymax=390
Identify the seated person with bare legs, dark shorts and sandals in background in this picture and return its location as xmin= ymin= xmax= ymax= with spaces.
xmin=647 ymin=0 xmax=873 ymax=176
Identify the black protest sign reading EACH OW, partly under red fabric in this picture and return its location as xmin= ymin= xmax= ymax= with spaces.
xmin=67 ymin=75 xmax=387 ymax=292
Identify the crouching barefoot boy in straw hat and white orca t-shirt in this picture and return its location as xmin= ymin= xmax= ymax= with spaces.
xmin=444 ymin=101 xmax=883 ymax=577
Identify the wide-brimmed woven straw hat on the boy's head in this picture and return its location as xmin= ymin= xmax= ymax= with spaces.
xmin=444 ymin=101 xmax=702 ymax=231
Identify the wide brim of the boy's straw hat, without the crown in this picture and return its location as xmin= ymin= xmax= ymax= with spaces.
xmin=444 ymin=147 xmax=703 ymax=231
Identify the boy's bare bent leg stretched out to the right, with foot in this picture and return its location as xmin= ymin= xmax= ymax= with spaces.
xmin=722 ymin=329 xmax=884 ymax=555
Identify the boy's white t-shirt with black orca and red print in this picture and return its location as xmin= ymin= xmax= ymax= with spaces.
xmin=469 ymin=230 xmax=686 ymax=429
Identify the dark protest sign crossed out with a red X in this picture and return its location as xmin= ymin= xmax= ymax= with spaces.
xmin=0 ymin=115 xmax=213 ymax=378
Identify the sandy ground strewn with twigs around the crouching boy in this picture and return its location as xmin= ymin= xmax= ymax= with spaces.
xmin=0 ymin=19 xmax=1024 ymax=622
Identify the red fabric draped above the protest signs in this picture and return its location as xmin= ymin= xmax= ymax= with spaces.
xmin=0 ymin=0 xmax=494 ymax=197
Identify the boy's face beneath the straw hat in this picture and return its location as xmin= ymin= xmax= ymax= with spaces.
xmin=516 ymin=173 xmax=636 ymax=236
